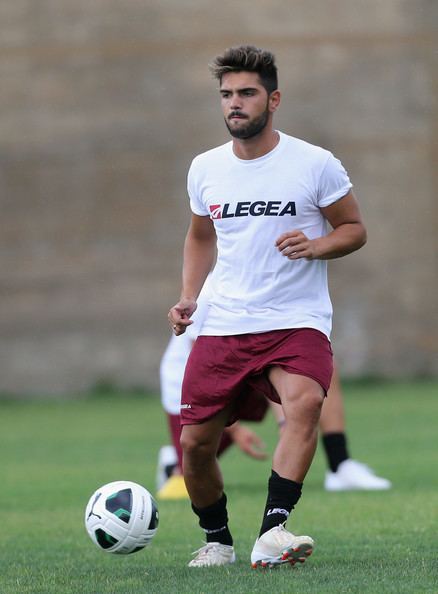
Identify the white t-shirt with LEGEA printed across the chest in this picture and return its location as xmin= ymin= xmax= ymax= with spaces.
xmin=188 ymin=132 xmax=352 ymax=337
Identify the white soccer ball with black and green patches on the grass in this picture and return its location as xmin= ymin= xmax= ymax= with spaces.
xmin=85 ymin=481 xmax=158 ymax=555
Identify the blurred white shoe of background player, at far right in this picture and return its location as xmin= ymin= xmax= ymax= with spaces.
xmin=324 ymin=460 xmax=392 ymax=491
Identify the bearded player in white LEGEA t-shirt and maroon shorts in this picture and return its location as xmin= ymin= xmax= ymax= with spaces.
xmin=168 ymin=46 xmax=366 ymax=567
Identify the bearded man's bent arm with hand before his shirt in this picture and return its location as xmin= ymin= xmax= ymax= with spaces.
xmin=276 ymin=191 xmax=367 ymax=260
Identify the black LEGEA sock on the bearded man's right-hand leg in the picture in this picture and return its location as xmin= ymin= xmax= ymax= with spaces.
xmin=259 ymin=470 xmax=303 ymax=536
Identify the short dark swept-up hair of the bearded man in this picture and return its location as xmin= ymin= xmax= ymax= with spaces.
xmin=210 ymin=45 xmax=278 ymax=94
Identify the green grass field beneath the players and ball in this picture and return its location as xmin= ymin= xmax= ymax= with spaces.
xmin=0 ymin=382 xmax=438 ymax=594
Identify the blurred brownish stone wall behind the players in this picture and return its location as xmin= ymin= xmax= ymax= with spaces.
xmin=0 ymin=0 xmax=438 ymax=395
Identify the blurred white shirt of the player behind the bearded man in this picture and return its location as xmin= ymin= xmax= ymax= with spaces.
xmin=160 ymin=276 xmax=211 ymax=415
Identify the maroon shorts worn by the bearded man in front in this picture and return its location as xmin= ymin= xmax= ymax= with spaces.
xmin=181 ymin=328 xmax=333 ymax=425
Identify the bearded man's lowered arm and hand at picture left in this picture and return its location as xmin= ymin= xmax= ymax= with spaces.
xmin=168 ymin=214 xmax=216 ymax=336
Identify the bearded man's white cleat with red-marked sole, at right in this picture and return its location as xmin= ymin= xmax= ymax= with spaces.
xmin=251 ymin=524 xmax=315 ymax=569
